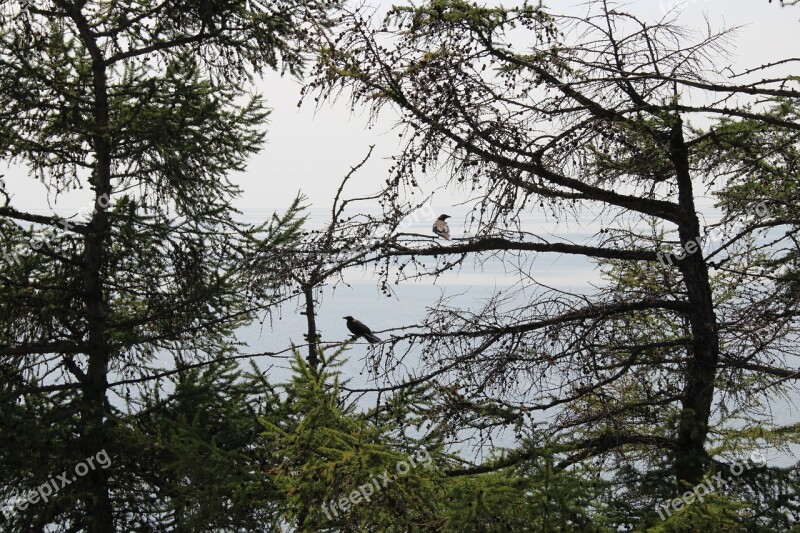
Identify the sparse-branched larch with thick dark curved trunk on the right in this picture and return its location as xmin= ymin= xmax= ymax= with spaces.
xmin=307 ymin=0 xmax=800 ymax=516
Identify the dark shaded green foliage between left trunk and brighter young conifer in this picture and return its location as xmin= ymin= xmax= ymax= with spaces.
xmin=116 ymin=362 xmax=277 ymax=531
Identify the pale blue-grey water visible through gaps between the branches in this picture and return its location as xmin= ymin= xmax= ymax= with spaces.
xmin=233 ymin=209 xmax=800 ymax=466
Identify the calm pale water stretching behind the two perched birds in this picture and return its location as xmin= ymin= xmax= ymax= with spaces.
xmin=234 ymin=204 xmax=600 ymax=378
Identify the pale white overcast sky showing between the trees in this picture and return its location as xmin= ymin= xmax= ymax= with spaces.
xmin=5 ymin=0 xmax=800 ymax=212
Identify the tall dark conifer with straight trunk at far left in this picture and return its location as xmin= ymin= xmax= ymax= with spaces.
xmin=0 ymin=0 xmax=336 ymax=531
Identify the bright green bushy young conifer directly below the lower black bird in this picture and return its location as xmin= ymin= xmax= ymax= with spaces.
xmin=262 ymin=352 xmax=441 ymax=531
